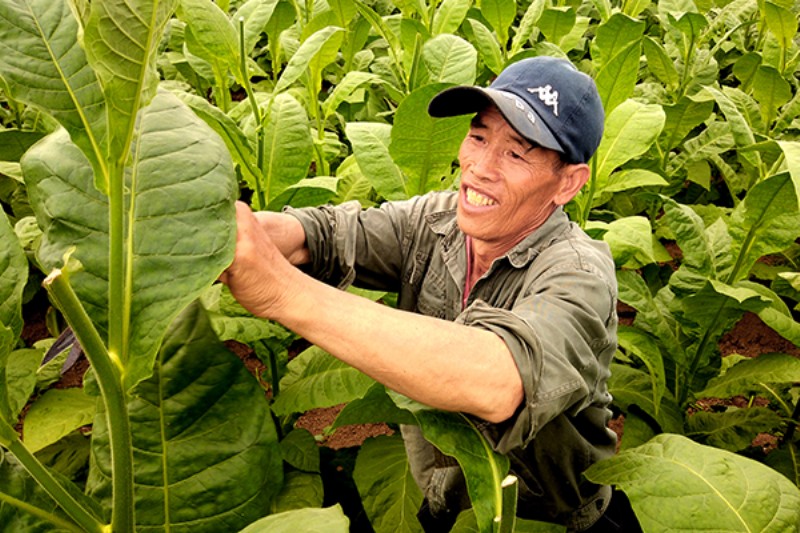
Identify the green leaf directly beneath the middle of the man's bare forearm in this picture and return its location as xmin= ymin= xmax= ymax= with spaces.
xmin=272 ymin=346 xmax=374 ymax=415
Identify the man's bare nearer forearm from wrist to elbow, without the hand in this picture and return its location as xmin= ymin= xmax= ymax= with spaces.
xmin=270 ymin=264 xmax=523 ymax=422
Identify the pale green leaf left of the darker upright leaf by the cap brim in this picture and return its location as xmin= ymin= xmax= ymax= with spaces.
xmin=345 ymin=122 xmax=409 ymax=200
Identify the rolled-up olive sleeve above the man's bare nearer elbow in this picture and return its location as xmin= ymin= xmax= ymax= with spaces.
xmin=458 ymin=256 xmax=616 ymax=453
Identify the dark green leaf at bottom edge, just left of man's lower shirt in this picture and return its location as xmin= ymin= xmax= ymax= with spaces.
xmin=353 ymin=435 xmax=422 ymax=533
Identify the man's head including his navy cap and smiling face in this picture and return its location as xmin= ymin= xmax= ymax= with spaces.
xmin=428 ymin=57 xmax=603 ymax=257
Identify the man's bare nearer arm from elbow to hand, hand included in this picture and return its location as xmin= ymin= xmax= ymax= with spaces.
xmin=220 ymin=204 xmax=523 ymax=422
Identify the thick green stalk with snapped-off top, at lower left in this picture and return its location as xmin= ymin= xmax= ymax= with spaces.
xmin=44 ymin=270 xmax=135 ymax=533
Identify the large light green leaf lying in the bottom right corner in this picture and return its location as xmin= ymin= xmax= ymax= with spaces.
xmin=586 ymin=434 xmax=800 ymax=532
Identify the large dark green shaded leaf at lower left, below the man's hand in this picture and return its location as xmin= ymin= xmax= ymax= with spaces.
xmin=88 ymin=303 xmax=283 ymax=532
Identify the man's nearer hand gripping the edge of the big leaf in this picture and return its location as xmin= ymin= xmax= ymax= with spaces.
xmin=219 ymin=202 xmax=298 ymax=318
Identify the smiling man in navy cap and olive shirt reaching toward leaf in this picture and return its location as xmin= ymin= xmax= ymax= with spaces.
xmin=220 ymin=57 xmax=635 ymax=532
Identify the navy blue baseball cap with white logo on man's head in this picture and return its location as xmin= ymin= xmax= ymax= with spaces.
xmin=428 ymin=56 xmax=605 ymax=163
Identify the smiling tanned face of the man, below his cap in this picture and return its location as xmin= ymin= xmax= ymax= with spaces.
xmin=458 ymin=106 xmax=571 ymax=254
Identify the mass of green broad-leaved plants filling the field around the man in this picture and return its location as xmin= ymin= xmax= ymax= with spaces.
xmin=0 ymin=0 xmax=800 ymax=532
